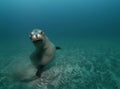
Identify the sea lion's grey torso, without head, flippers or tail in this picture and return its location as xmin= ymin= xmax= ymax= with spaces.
xmin=30 ymin=37 xmax=56 ymax=66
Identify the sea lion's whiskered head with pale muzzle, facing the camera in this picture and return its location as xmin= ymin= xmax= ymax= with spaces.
xmin=29 ymin=29 xmax=44 ymax=43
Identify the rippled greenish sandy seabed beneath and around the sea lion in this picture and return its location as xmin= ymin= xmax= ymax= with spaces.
xmin=0 ymin=41 xmax=120 ymax=89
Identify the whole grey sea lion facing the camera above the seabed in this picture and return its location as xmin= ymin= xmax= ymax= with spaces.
xmin=29 ymin=29 xmax=60 ymax=77
